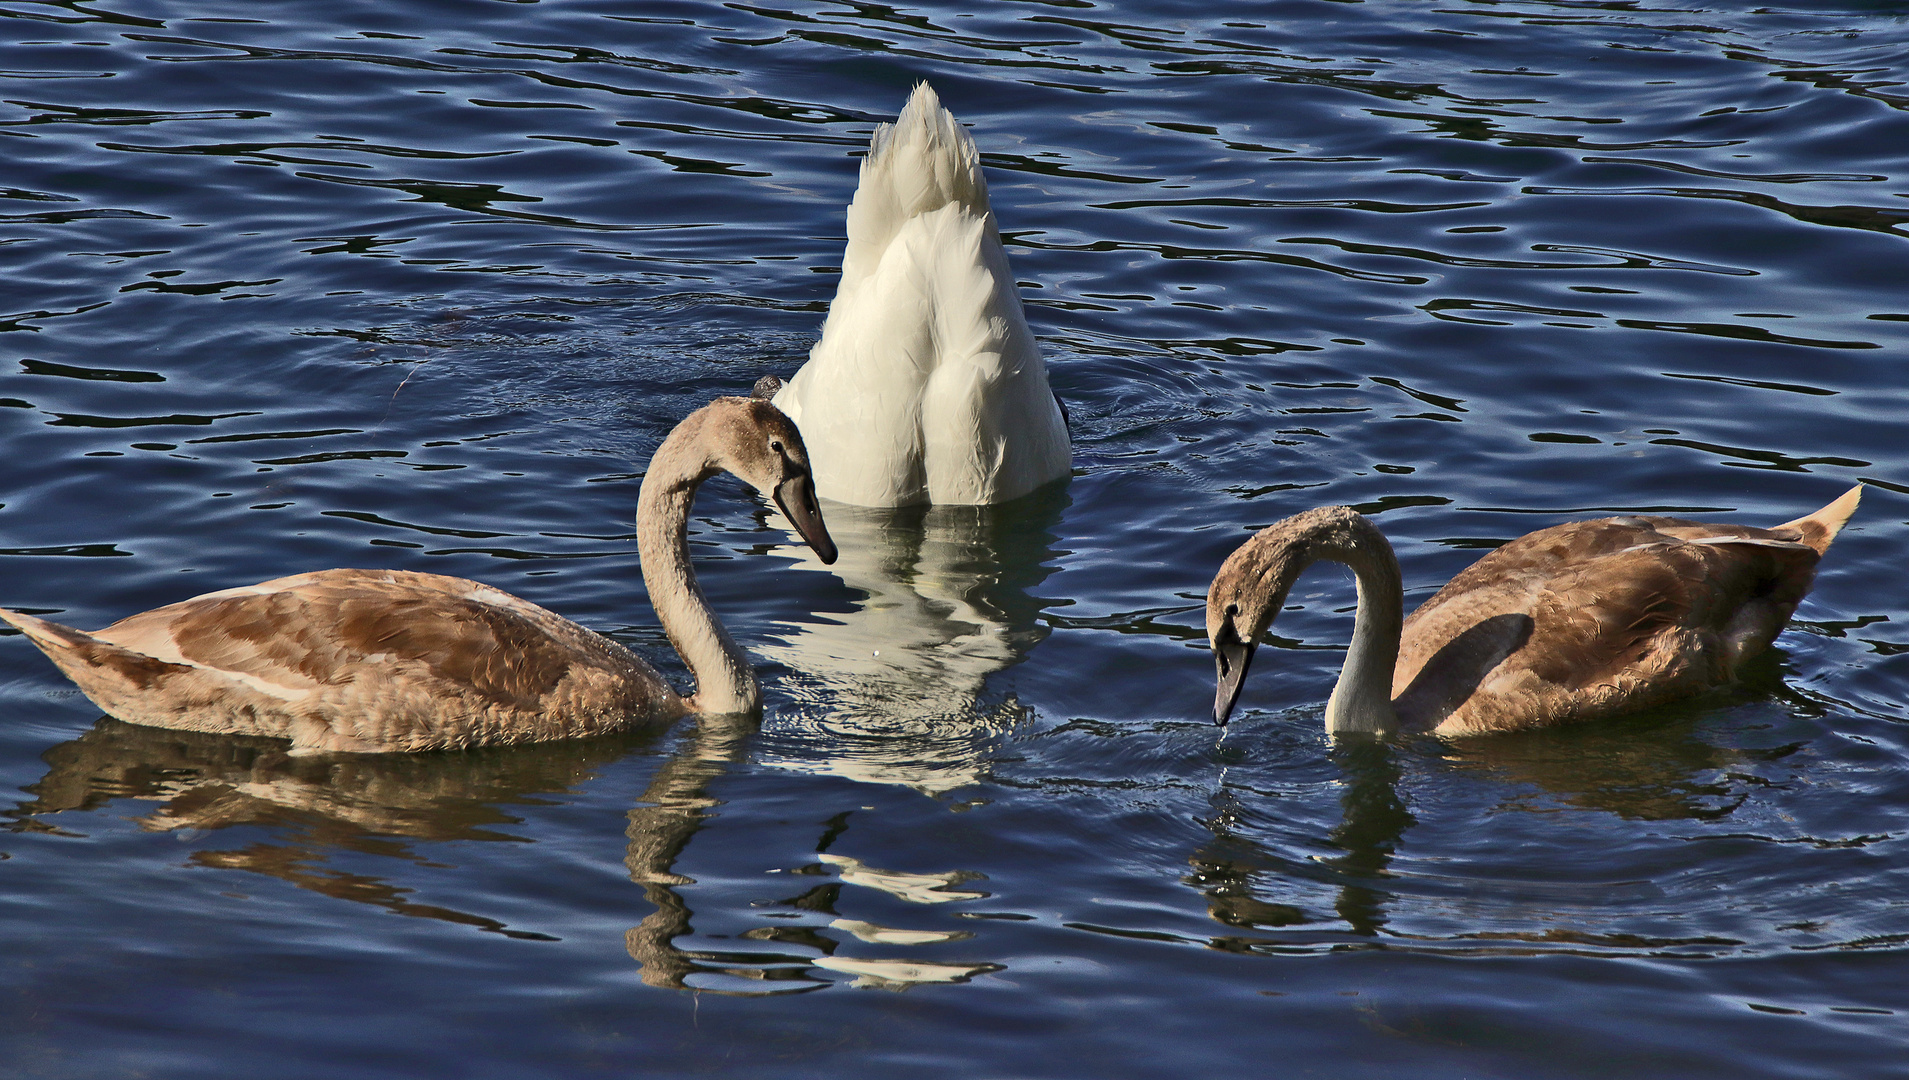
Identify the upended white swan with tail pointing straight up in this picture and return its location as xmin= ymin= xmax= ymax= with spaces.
xmin=773 ymin=82 xmax=1071 ymax=506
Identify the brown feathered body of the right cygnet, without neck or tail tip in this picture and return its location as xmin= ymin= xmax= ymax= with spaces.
xmin=1394 ymin=517 xmax=1817 ymax=735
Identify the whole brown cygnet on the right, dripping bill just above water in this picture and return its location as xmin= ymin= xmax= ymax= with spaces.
xmin=1206 ymin=487 xmax=1863 ymax=735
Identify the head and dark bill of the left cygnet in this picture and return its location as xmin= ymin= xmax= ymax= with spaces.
xmin=697 ymin=397 xmax=836 ymax=563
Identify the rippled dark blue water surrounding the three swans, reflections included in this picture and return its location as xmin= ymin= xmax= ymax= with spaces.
xmin=0 ymin=0 xmax=1909 ymax=1080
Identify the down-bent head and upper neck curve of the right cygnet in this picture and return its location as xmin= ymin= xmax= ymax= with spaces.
xmin=1206 ymin=506 xmax=1376 ymax=723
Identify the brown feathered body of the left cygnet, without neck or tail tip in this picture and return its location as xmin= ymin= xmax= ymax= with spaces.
xmin=67 ymin=571 xmax=682 ymax=752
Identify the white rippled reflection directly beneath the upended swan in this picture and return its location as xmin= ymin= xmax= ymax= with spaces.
xmin=760 ymin=488 xmax=1069 ymax=794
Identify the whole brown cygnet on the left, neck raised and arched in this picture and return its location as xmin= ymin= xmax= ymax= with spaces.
xmin=0 ymin=397 xmax=836 ymax=754
